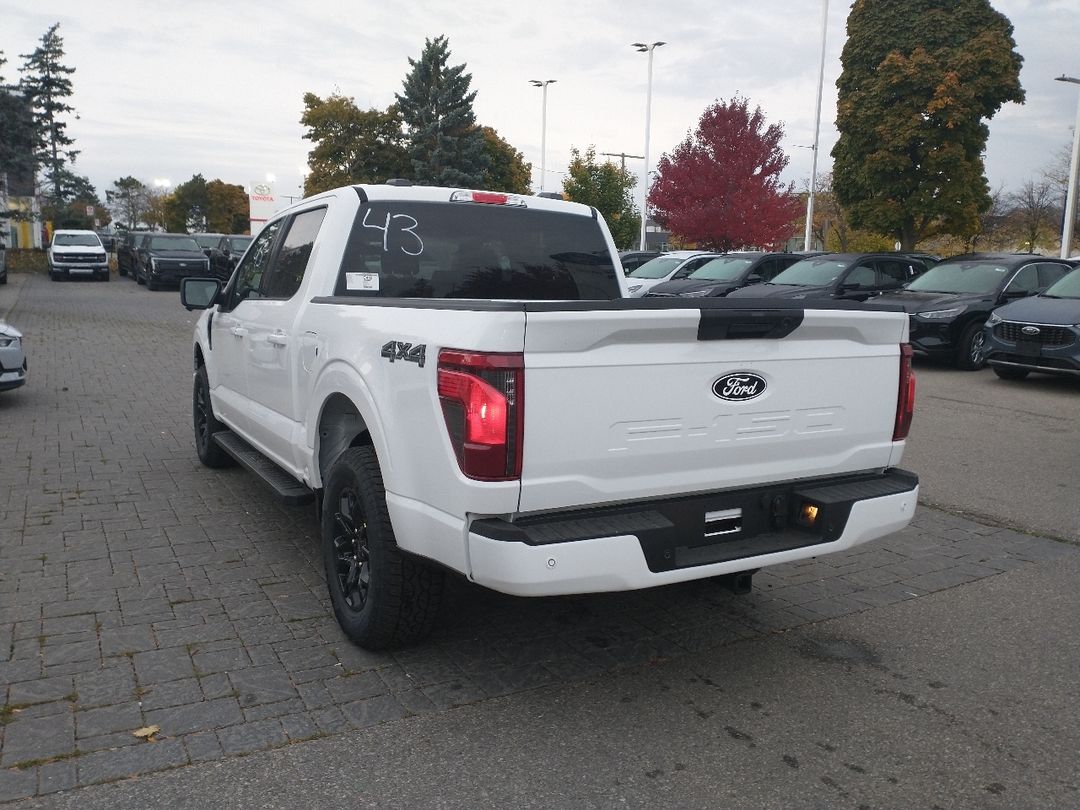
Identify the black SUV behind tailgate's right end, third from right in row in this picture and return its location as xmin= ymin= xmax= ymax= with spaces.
xmin=730 ymin=253 xmax=927 ymax=301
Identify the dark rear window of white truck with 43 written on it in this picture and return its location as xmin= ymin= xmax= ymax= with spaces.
xmin=335 ymin=202 xmax=621 ymax=300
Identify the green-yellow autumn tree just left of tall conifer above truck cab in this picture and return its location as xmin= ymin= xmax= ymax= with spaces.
xmin=300 ymin=93 xmax=411 ymax=195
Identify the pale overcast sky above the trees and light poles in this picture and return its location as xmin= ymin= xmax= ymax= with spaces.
xmin=0 ymin=0 xmax=1080 ymax=216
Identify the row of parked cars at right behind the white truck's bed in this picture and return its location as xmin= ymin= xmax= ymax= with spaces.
xmin=627 ymin=251 xmax=1080 ymax=379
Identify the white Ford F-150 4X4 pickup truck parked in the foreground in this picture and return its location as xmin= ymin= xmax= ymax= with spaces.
xmin=181 ymin=185 xmax=918 ymax=648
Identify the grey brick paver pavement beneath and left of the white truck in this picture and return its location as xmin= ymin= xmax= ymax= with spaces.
xmin=0 ymin=271 xmax=1080 ymax=800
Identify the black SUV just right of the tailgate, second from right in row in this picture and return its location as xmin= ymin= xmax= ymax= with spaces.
xmin=879 ymin=253 xmax=1072 ymax=372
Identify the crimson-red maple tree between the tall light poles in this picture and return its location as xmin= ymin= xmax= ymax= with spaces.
xmin=648 ymin=96 xmax=799 ymax=251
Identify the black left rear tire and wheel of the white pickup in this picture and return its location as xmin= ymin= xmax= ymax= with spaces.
xmin=321 ymin=447 xmax=445 ymax=650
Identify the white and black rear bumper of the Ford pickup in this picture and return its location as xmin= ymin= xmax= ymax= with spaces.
xmin=468 ymin=470 xmax=919 ymax=596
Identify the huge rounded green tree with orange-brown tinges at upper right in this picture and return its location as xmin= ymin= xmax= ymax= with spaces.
xmin=833 ymin=0 xmax=1024 ymax=249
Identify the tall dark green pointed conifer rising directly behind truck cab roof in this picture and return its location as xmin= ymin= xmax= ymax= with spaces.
xmin=396 ymin=37 xmax=488 ymax=188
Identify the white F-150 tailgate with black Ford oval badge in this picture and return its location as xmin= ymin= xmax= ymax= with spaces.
xmin=519 ymin=302 xmax=907 ymax=512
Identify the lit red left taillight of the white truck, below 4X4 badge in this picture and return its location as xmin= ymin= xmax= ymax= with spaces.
xmin=438 ymin=349 xmax=525 ymax=481
